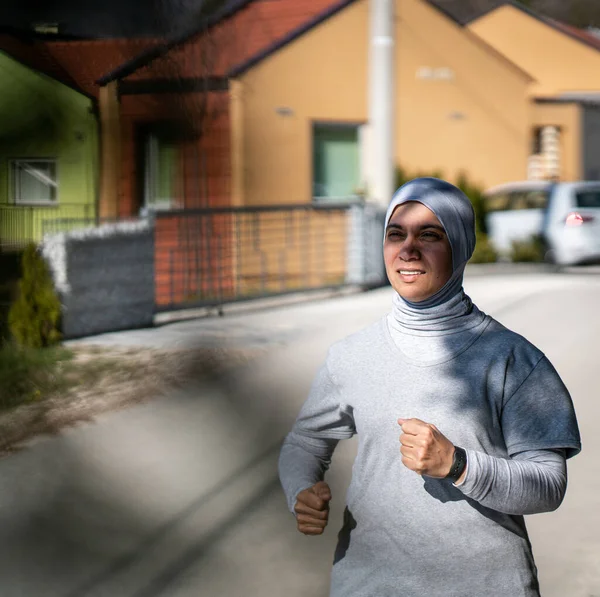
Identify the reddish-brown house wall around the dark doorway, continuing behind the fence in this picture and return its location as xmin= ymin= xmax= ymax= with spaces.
xmin=120 ymin=93 xmax=233 ymax=305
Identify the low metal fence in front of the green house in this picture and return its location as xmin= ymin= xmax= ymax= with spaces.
xmin=0 ymin=203 xmax=96 ymax=251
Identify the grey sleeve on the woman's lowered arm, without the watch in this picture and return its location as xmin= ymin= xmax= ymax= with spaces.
xmin=279 ymin=354 xmax=356 ymax=512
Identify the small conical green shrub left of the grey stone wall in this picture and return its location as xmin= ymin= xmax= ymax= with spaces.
xmin=8 ymin=244 xmax=60 ymax=348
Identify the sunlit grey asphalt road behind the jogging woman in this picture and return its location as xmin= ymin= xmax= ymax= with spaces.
xmin=0 ymin=270 xmax=600 ymax=597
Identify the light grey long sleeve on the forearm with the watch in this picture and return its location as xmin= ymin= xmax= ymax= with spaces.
xmin=456 ymin=450 xmax=567 ymax=514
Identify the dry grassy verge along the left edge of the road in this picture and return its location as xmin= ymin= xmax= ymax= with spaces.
xmin=0 ymin=345 xmax=258 ymax=457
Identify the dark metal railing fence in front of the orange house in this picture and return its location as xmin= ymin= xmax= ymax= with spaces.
xmin=155 ymin=202 xmax=381 ymax=311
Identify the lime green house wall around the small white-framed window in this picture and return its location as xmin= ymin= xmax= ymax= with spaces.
xmin=0 ymin=52 xmax=98 ymax=248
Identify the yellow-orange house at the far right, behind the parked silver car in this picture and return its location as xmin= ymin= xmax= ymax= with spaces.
xmin=468 ymin=2 xmax=600 ymax=180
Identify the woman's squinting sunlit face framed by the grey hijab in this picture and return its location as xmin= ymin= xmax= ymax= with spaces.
xmin=383 ymin=201 xmax=452 ymax=303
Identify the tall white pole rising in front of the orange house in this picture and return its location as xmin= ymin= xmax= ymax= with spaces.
xmin=368 ymin=0 xmax=395 ymax=207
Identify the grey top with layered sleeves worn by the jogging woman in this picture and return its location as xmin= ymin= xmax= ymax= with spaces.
xmin=279 ymin=314 xmax=580 ymax=597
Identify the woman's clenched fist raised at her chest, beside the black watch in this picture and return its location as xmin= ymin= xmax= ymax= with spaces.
xmin=398 ymin=419 xmax=454 ymax=479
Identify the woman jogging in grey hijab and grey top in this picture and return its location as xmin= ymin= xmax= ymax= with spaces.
xmin=279 ymin=178 xmax=581 ymax=597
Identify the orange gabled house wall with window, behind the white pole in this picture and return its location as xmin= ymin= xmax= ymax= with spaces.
xmin=229 ymin=0 xmax=534 ymax=205
